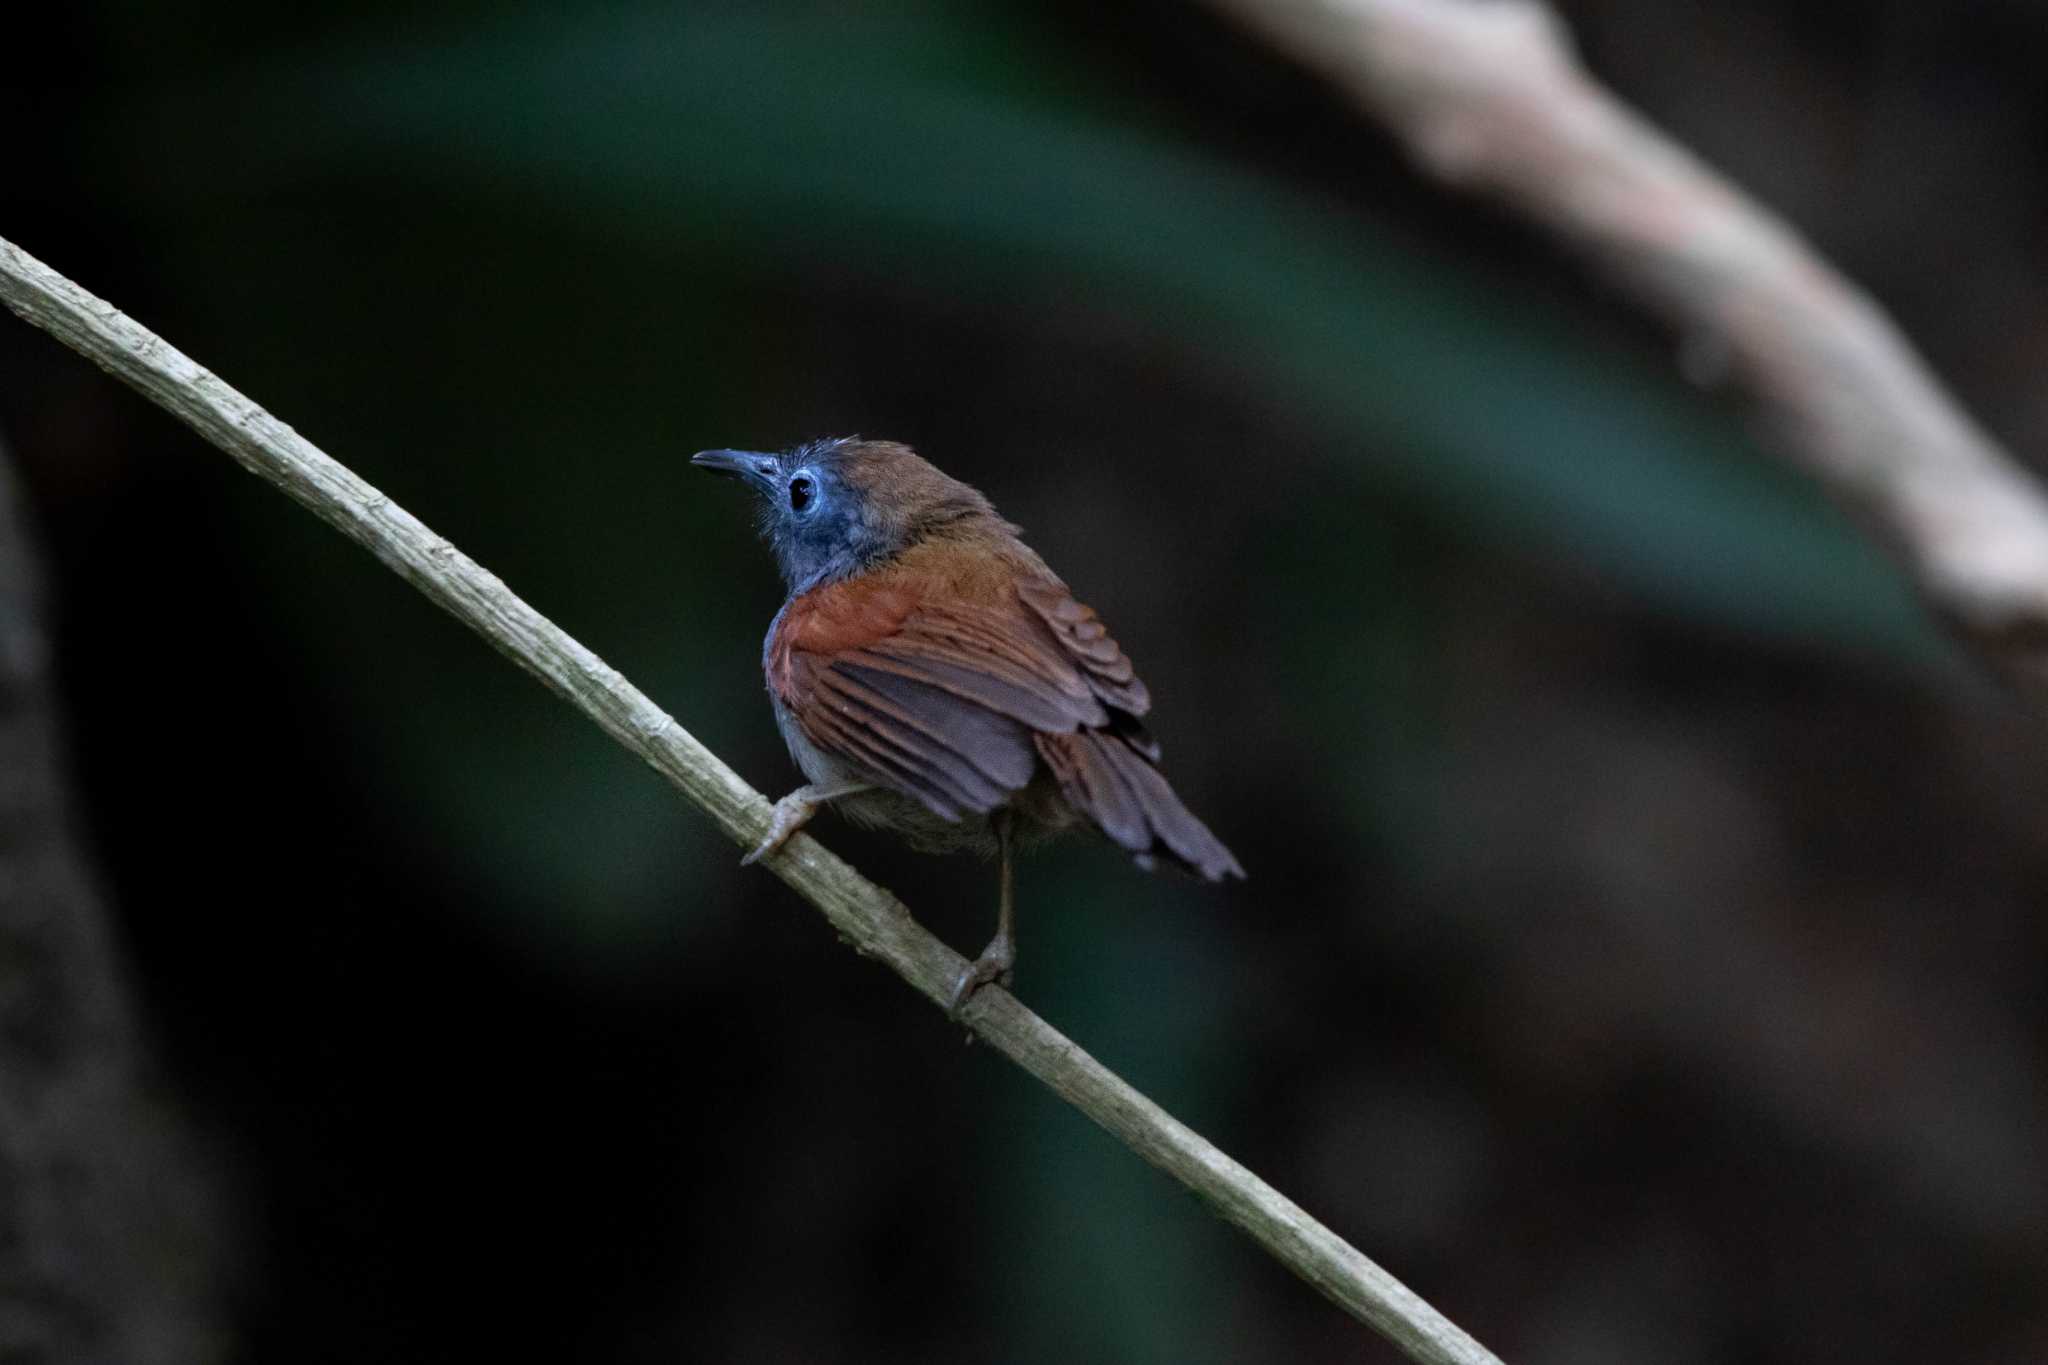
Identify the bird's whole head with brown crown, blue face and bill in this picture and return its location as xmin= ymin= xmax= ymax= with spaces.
xmin=690 ymin=436 xmax=1004 ymax=591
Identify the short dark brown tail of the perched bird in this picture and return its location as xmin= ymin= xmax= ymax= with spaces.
xmin=1034 ymin=731 xmax=1245 ymax=882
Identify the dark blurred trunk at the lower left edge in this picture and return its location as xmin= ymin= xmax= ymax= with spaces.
xmin=0 ymin=429 xmax=227 ymax=1365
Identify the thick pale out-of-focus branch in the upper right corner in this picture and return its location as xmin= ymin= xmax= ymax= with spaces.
xmin=1208 ymin=0 xmax=2048 ymax=706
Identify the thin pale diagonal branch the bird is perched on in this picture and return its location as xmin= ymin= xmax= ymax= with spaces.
xmin=0 ymin=241 xmax=1499 ymax=1365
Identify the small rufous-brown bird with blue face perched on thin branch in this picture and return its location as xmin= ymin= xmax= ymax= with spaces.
xmin=690 ymin=436 xmax=1245 ymax=1017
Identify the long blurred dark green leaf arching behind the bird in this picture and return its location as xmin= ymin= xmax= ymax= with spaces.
xmin=132 ymin=2 xmax=1925 ymax=651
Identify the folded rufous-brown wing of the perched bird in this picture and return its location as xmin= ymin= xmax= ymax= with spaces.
xmin=768 ymin=581 xmax=1147 ymax=821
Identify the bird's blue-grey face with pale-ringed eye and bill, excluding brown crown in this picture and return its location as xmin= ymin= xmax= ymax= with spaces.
xmin=690 ymin=440 xmax=891 ymax=591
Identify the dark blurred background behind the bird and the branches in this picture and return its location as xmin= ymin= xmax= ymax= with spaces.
xmin=0 ymin=0 xmax=2048 ymax=1365
